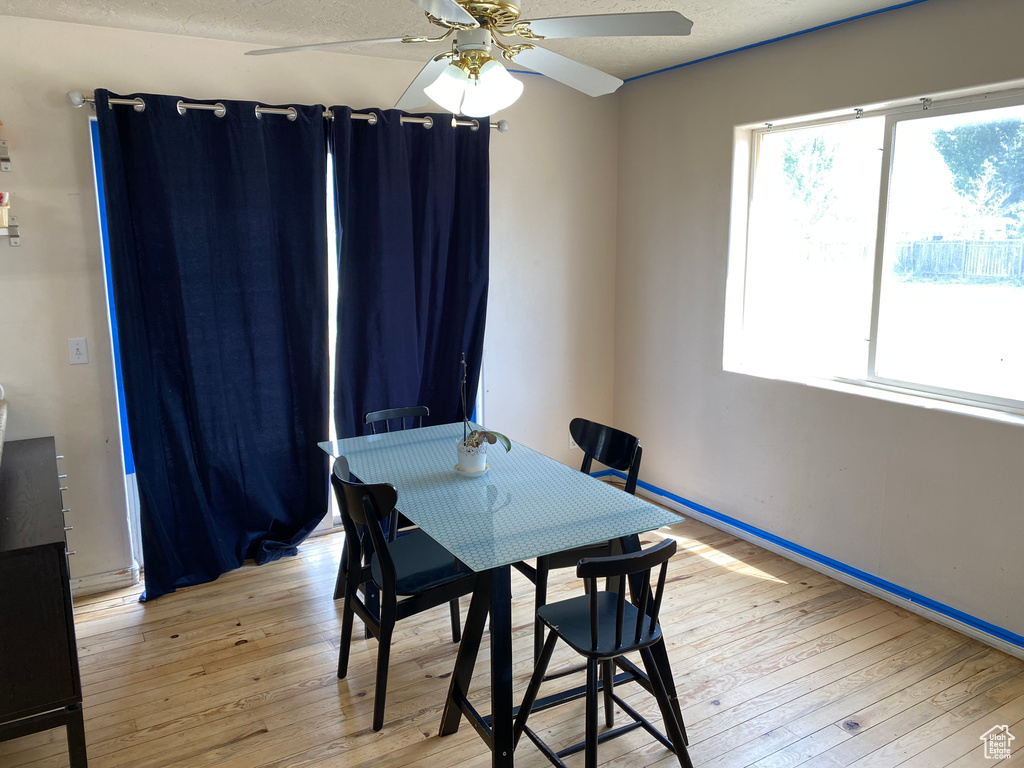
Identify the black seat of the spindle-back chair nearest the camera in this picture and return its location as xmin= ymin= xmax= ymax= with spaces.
xmin=537 ymin=592 xmax=662 ymax=658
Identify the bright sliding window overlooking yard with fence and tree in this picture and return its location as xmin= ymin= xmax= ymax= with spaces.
xmin=725 ymin=88 xmax=1024 ymax=411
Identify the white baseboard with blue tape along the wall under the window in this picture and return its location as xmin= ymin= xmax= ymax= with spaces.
xmin=637 ymin=487 xmax=1024 ymax=658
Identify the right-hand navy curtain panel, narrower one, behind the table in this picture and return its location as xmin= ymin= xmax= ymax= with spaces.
xmin=331 ymin=106 xmax=489 ymax=437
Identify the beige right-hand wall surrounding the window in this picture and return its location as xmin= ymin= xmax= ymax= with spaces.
xmin=614 ymin=0 xmax=1024 ymax=634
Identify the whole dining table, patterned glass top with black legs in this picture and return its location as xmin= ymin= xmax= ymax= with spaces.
xmin=318 ymin=423 xmax=683 ymax=768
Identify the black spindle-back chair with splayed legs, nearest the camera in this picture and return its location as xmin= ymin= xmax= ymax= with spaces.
xmin=513 ymin=539 xmax=693 ymax=768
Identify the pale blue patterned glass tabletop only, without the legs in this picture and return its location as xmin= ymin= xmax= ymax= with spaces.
xmin=318 ymin=424 xmax=680 ymax=571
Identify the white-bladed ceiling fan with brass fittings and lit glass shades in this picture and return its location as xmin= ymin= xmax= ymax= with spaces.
xmin=247 ymin=0 xmax=693 ymax=117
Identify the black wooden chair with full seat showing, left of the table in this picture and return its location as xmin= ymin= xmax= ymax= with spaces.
xmin=331 ymin=460 xmax=476 ymax=731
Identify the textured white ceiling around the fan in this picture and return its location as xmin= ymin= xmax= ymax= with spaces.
xmin=0 ymin=0 xmax=913 ymax=78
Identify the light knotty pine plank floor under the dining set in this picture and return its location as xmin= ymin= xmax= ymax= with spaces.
xmin=6 ymin=507 xmax=1024 ymax=768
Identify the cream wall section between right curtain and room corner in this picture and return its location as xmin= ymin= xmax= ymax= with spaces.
xmin=483 ymin=76 xmax=618 ymax=465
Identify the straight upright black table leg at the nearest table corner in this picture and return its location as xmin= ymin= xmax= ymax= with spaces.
xmin=490 ymin=565 xmax=515 ymax=768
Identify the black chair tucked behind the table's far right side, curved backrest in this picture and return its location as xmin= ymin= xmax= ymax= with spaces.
xmin=515 ymin=419 xmax=643 ymax=662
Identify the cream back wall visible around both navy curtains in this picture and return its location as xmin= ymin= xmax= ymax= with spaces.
xmin=0 ymin=16 xmax=617 ymax=578
